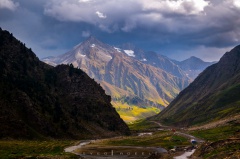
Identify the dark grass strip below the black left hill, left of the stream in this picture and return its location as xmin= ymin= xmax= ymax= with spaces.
xmin=0 ymin=140 xmax=77 ymax=159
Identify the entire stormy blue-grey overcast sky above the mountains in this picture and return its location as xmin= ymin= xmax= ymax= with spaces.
xmin=0 ymin=0 xmax=240 ymax=61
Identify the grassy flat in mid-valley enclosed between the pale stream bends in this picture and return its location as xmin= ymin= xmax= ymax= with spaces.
xmin=63 ymin=121 xmax=195 ymax=159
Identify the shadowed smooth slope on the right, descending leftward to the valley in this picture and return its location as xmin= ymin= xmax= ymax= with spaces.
xmin=152 ymin=45 xmax=240 ymax=126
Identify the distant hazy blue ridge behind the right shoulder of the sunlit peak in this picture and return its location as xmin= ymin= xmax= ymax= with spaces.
xmin=118 ymin=43 xmax=216 ymax=81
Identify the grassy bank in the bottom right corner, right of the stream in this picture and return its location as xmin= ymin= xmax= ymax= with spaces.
xmin=190 ymin=119 xmax=240 ymax=159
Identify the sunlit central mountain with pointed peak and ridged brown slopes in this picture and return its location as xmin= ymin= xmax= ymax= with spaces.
xmin=43 ymin=36 xmax=189 ymax=120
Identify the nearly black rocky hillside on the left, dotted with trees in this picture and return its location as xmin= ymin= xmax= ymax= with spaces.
xmin=0 ymin=29 xmax=129 ymax=139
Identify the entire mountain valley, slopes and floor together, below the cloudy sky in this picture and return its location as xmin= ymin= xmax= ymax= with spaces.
xmin=0 ymin=27 xmax=240 ymax=159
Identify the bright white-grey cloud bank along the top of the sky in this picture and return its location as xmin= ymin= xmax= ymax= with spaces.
xmin=44 ymin=0 xmax=210 ymax=32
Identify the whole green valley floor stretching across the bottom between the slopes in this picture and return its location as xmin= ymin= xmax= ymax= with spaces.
xmin=0 ymin=115 xmax=240 ymax=159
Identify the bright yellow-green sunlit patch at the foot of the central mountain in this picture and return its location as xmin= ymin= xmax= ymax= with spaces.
xmin=112 ymin=102 xmax=160 ymax=123
